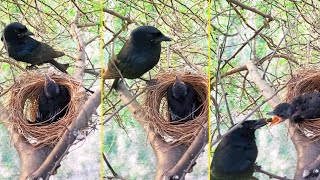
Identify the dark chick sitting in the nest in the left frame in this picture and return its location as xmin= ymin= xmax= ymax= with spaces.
xmin=35 ymin=75 xmax=70 ymax=124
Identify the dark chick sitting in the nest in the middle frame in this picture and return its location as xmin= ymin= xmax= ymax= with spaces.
xmin=167 ymin=77 xmax=200 ymax=123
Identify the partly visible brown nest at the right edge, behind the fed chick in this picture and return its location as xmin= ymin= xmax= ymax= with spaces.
xmin=285 ymin=67 xmax=320 ymax=139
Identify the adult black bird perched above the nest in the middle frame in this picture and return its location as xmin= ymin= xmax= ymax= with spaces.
xmin=104 ymin=26 xmax=171 ymax=84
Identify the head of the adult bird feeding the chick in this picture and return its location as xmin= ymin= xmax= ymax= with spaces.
xmin=233 ymin=119 xmax=268 ymax=138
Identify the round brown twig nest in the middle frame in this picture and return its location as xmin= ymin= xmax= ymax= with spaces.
xmin=145 ymin=73 xmax=208 ymax=146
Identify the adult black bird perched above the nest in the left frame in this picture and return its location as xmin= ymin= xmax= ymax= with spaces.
xmin=1 ymin=22 xmax=69 ymax=73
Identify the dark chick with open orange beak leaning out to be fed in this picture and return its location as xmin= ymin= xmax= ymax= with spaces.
xmin=267 ymin=92 xmax=320 ymax=124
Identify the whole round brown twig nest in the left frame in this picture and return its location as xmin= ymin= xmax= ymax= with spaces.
xmin=8 ymin=72 xmax=85 ymax=147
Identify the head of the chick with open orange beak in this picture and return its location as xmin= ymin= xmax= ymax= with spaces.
xmin=267 ymin=103 xmax=294 ymax=125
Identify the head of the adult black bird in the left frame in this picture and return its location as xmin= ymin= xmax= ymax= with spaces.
xmin=1 ymin=22 xmax=34 ymax=42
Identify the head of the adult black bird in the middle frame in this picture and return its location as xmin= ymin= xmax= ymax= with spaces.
xmin=131 ymin=26 xmax=171 ymax=45
